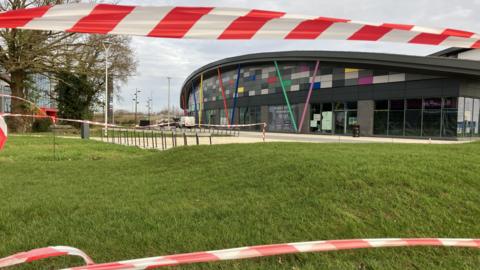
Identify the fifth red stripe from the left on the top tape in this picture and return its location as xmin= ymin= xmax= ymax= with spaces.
xmin=285 ymin=17 xmax=348 ymax=39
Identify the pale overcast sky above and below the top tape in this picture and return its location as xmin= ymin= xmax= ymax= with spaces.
xmin=110 ymin=0 xmax=480 ymax=111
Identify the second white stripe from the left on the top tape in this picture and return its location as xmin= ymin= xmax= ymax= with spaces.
xmin=110 ymin=6 xmax=172 ymax=36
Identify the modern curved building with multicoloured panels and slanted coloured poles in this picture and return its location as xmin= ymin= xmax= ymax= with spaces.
xmin=180 ymin=48 xmax=480 ymax=139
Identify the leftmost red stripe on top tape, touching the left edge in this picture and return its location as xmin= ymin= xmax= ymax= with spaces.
xmin=0 ymin=6 xmax=51 ymax=28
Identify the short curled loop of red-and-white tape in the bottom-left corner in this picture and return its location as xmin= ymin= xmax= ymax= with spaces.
xmin=0 ymin=246 xmax=94 ymax=268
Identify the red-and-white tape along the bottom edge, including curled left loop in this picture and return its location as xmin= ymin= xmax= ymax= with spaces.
xmin=0 ymin=238 xmax=480 ymax=270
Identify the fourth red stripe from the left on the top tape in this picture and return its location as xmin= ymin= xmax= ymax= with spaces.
xmin=218 ymin=9 xmax=285 ymax=39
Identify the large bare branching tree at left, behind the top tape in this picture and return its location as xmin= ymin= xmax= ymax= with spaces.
xmin=0 ymin=0 xmax=136 ymax=131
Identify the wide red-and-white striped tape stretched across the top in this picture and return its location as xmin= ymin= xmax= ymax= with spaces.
xmin=0 ymin=3 xmax=480 ymax=48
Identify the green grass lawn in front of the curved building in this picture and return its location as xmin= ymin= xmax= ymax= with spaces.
xmin=0 ymin=137 xmax=480 ymax=269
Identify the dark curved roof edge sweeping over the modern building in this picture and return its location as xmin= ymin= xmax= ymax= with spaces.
xmin=180 ymin=51 xmax=480 ymax=106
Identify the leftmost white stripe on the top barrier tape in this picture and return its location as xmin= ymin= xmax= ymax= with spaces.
xmin=20 ymin=3 xmax=96 ymax=31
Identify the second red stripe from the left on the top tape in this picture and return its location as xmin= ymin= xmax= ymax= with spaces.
xmin=67 ymin=4 xmax=135 ymax=34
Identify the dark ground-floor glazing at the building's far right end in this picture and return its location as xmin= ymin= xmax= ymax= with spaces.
xmin=373 ymin=97 xmax=480 ymax=138
